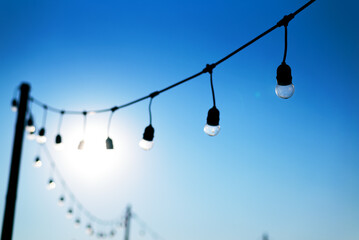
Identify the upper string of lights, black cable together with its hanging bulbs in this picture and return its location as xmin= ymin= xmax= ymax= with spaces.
xmin=22 ymin=0 xmax=315 ymax=150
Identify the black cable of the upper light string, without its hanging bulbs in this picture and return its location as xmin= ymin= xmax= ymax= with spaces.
xmin=26 ymin=0 xmax=316 ymax=114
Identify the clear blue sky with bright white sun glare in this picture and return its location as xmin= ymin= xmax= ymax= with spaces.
xmin=0 ymin=0 xmax=359 ymax=240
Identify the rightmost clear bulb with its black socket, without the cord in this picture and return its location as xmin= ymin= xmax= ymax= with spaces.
xmin=275 ymin=62 xmax=294 ymax=99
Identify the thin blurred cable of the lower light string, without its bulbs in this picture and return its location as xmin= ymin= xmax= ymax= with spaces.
xmin=39 ymin=143 xmax=122 ymax=226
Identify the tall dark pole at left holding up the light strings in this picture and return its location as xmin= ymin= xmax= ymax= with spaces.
xmin=1 ymin=83 xmax=30 ymax=240
